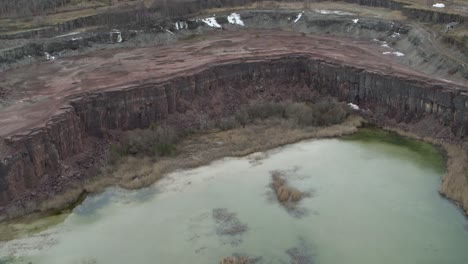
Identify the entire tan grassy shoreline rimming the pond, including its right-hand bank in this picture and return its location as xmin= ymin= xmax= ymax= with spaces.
xmin=0 ymin=112 xmax=468 ymax=236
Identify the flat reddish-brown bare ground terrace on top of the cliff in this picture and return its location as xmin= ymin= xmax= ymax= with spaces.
xmin=0 ymin=31 xmax=468 ymax=137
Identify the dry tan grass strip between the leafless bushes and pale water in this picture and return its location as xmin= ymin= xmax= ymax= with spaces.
xmin=32 ymin=115 xmax=363 ymax=216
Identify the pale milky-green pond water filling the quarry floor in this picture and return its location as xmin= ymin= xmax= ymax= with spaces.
xmin=0 ymin=129 xmax=468 ymax=264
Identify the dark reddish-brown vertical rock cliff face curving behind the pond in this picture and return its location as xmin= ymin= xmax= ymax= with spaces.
xmin=0 ymin=55 xmax=468 ymax=214
